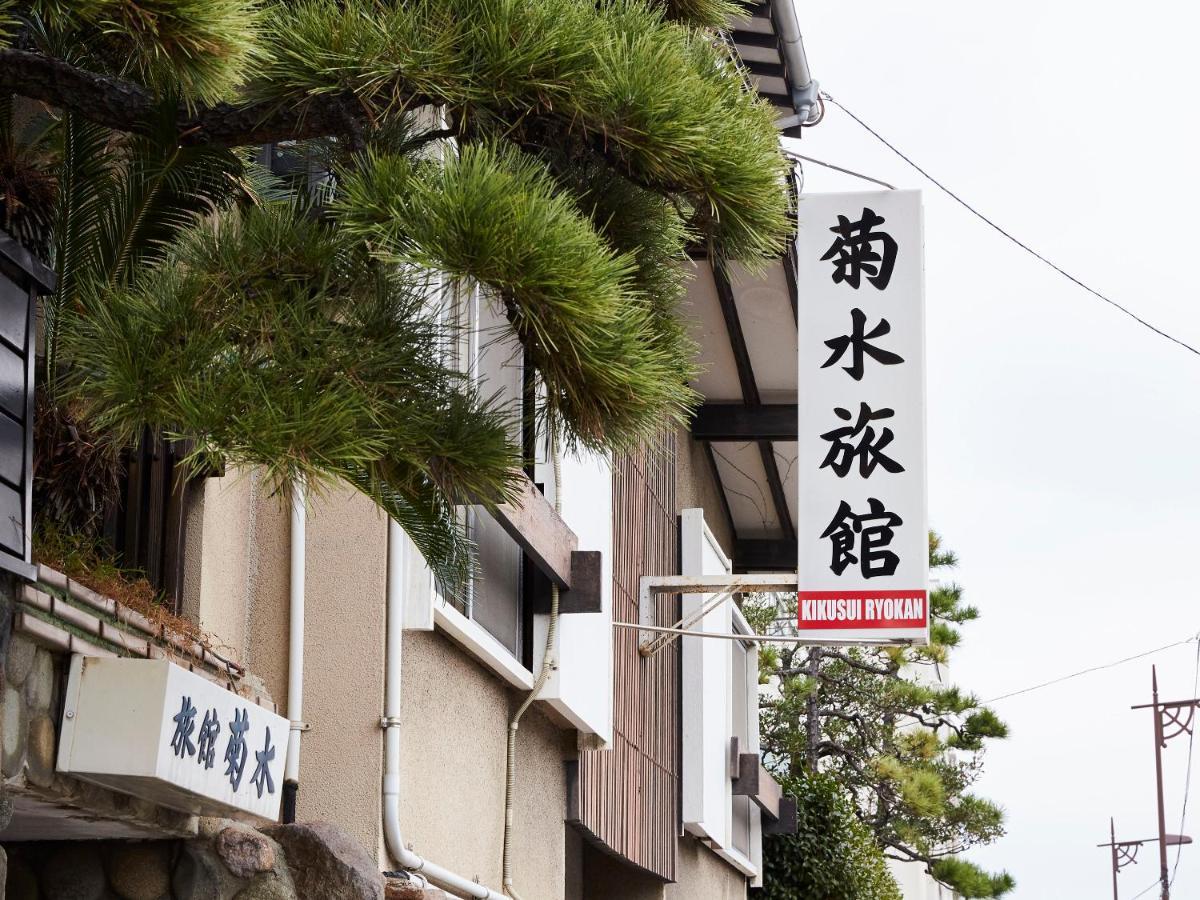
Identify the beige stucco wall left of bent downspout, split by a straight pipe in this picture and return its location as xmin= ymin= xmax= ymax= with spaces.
xmin=184 ymin=480 xmax=388 ymax=856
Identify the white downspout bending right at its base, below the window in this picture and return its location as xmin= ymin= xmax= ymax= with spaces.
xmin=380 ymin=520 xmax=503 ymax=900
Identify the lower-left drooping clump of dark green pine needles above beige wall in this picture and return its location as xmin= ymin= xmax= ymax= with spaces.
xmin=65 ymin=203 xmax=512 ymax=578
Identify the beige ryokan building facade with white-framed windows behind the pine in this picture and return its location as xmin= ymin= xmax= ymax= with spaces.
xmin=0 ymin=0 xmax=816 ymax=900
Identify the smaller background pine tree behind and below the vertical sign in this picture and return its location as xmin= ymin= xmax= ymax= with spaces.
xmin=746 ymin=534 xmax=1012 ymax=896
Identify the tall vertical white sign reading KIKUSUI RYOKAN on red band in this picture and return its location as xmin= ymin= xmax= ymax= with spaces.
xmin=797 ymin=191 xmax=929 ymax=643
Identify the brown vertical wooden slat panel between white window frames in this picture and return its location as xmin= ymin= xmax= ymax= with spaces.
xmin=580 ymin=436 xmax=679 ymax=880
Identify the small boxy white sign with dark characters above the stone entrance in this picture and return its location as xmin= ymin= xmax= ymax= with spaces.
xmin=58 ymin=656 xmax=288 ymax=820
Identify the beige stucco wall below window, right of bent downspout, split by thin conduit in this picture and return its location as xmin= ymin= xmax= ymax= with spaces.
xmin=401 ymin=631 xmax=575 ymax=900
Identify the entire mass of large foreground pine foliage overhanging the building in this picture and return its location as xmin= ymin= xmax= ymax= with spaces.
xmin=0 ymin=0 xmax=790 ymax=584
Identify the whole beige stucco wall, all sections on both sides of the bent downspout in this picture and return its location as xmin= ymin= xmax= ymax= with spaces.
xmin=184 ymin=473 xmax=575 ymax=900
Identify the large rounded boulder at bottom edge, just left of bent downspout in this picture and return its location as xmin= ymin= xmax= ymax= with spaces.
xmin=262 ymin=822 xmax=384 ymax=900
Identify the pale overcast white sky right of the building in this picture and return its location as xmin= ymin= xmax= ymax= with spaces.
xmin=782 ymin=0 xmax=1200 ymax=900
